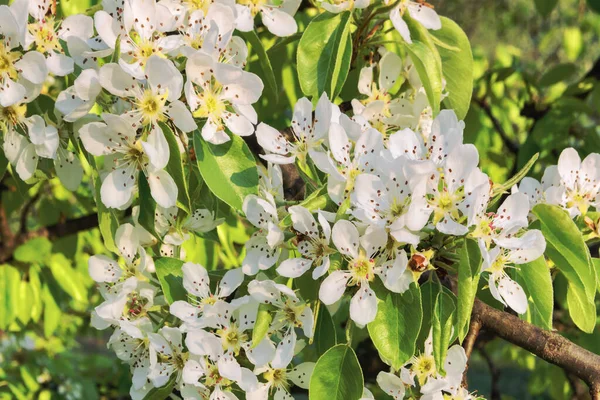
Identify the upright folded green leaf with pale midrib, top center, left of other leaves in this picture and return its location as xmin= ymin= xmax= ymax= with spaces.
xmin=297 ymin=11 xmax=352 ymax=100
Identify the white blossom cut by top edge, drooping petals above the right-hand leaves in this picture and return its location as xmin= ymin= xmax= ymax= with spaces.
xmin=385 ymin=0 xmax=442 ymax=43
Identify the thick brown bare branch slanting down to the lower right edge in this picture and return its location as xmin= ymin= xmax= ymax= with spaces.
xmin=471 ymin=299 xmax=600 ymax=400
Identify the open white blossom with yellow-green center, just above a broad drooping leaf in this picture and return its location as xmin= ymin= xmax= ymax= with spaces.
xmin=185 ymin=51 xmax=264 ymax=144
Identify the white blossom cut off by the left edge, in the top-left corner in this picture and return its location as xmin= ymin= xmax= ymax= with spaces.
xmin=0 ymin=0 xmax=48 ymax=107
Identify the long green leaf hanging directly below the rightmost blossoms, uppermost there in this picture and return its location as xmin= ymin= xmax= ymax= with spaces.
xmin=533 ymin=204 xmax=596 ymax=302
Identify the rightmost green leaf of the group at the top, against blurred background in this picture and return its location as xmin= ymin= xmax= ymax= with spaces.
xmin=429 ymin=17 xmax=473 ymax=119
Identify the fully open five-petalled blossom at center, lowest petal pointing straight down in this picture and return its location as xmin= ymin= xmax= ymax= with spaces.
xmin=319 ymin=220 xmax=406 ymax=326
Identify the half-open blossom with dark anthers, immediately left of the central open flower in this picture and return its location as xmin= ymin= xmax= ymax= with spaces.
xmin=277 ymin=206 xmax=334 ymax=279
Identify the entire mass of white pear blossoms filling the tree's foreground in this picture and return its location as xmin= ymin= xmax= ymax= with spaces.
xmin=0 ymin=0 xmax=600 ymax=400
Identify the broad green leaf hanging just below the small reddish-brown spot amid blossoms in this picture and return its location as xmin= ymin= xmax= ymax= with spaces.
xmin=367 ymin=284 xmax=423 ymax=369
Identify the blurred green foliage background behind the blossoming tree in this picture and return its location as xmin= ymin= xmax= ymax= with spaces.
xmin=0 ymin=0 xmax=600 ymax=400
